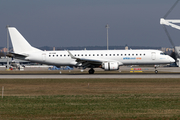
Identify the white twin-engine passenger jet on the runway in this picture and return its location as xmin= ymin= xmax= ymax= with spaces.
xmin=8 ymin=27 xmax=175 ymax=74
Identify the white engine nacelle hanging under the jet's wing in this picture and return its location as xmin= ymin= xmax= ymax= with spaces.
xmin=102 ymin=62 xmax=119 ymax=71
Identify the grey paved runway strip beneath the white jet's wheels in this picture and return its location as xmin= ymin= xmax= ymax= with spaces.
xmin=0 ymin=73 xmax=180 ymax=79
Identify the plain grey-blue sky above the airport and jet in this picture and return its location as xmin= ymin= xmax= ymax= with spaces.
xmin=0 ymin=0 xmax=180 ymax=47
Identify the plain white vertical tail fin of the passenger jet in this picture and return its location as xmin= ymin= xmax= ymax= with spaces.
xmin=8 ymin=27 xmax=41 ymax=54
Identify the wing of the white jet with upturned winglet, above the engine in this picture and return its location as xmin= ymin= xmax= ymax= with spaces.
xmin=67 ymin=50 xmax=123 ymax=67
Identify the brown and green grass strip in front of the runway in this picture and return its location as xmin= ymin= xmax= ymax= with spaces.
xmin=0 ymin=79 xmax=180 ymax=120
